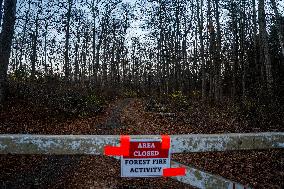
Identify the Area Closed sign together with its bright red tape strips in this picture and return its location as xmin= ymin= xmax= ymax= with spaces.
xmin=104 ymin=135 xmax=186 ymax=177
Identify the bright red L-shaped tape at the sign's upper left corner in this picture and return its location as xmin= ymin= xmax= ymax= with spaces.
xmin=104 ymin=135 xmax=130 ymax=156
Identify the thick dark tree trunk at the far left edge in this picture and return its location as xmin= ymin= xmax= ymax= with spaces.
xmin=0 ymin=0 xmax=17 ymax=103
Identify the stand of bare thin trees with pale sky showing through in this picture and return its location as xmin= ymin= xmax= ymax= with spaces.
xmin=1 ymin=0 xmax=284 ymax=102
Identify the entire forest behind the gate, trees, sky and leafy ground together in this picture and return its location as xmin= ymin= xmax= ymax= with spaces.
xmin=0 ymin=0 xmax=284 ymax=188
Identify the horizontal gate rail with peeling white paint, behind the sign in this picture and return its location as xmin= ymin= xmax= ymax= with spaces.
xmin=0 ymin=132 xmax=284 ymax=155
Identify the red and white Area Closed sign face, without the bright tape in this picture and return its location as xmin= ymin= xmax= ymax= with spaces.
xmin=121 ymin=139 xmax=170 ymax=177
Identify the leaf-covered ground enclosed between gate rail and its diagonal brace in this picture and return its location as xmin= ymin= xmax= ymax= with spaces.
xmin=173 ymin=149 xmax=284 ymax=188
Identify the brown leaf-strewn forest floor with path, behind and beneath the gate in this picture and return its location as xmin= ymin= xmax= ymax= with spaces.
xmin=0 ymin=98 xmax=284 ymax=188
